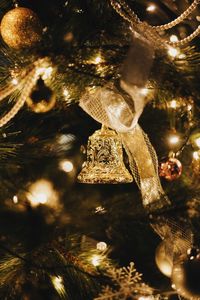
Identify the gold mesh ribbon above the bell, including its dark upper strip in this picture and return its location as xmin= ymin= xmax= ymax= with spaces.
xmin=79 ymin=33 xmax=169 ymax=211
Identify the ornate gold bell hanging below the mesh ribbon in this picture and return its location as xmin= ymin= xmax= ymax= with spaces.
xmin=78 ymin=126 xmax=133 ymax=184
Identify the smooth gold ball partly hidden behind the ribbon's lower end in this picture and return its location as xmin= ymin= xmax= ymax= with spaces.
xmin=155 ymin=241 xmax=173 ymax=277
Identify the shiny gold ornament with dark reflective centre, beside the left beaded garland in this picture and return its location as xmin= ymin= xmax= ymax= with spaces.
xmin=26 ymin=79 xmax=56 ymax=113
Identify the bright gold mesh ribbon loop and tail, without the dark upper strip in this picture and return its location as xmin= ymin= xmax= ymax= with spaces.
xmin=80 ymin=83 xmax=169 ymax=211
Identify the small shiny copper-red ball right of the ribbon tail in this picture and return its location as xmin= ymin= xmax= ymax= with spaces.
xmin=159 ymin=158 xmax=183 ymax=181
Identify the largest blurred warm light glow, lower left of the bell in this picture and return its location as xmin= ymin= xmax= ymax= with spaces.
xmin=27 ymin=179 xmax=58 ymax=207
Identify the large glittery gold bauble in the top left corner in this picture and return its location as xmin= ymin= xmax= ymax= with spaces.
xmin=1 ymin=7 xmax=42 ymax=49
